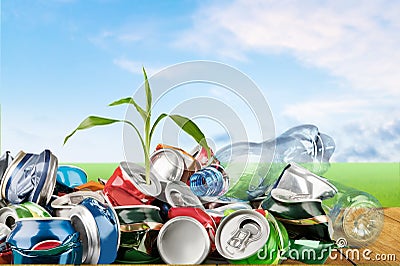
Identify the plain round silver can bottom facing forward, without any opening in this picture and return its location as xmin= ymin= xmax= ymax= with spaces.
xmin=157 ymin=216 xmax=211 ymax=264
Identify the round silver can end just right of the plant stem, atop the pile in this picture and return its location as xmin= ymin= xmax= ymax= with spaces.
xmin=150 ymin=148 xmax=185 ymax=182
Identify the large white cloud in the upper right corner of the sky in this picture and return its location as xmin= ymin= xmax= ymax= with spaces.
xmin=176 ymin=1 xmax=400 ymax=95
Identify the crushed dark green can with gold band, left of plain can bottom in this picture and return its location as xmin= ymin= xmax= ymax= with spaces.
xmin=114 ymin=205 xmax=163 ymax=264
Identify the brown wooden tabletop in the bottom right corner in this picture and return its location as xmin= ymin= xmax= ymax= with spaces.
xmin=284 ymin=207 xmax=400 ymax=265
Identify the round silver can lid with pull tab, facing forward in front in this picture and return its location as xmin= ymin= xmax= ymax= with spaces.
xmin=215 ymin=210 xmax=270 ymax=260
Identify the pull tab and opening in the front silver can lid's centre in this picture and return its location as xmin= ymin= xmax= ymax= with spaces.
xmin=226 ymin=219 xmax=261 ymax=255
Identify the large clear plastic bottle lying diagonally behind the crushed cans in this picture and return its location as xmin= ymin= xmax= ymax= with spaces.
xmin=190 ymin=125 xmax=335 ymax=200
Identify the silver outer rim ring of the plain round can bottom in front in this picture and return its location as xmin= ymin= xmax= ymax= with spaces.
xmin=157 ymin=216 xmax=211 ymax=264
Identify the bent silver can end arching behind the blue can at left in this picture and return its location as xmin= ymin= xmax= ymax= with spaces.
xmin=51 ymin=191 xmax=106 ymax=218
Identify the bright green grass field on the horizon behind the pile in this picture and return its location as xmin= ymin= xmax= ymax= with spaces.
xmin=68 ymin=163 xmax=400 ymax=207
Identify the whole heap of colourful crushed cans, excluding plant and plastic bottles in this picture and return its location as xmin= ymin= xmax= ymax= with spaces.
xmin=0 ymin=125 xmax=382 ymax=264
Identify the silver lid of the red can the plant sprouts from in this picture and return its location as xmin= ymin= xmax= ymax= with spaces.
xmin=120 ymin=162 xmax=161 ymax=197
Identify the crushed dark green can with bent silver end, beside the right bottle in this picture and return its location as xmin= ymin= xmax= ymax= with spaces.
xmin=261 ymin=163 xmax=337 ymax=242
